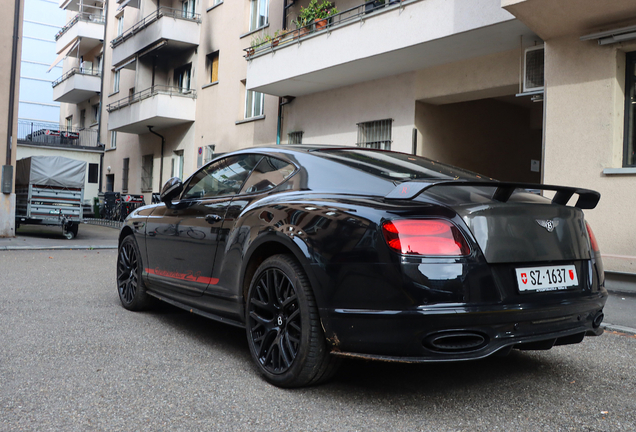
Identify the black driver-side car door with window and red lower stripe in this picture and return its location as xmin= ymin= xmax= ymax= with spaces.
xmin=146 ymin=154 xmax=262 ymax=296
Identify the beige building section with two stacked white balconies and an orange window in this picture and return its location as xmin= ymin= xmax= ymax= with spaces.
xmin=101 ymin=0 xmax=277 ymax=197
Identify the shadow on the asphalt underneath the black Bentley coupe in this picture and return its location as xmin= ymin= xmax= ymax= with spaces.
xmin=108 ymin=290 xmax=572 ymax=402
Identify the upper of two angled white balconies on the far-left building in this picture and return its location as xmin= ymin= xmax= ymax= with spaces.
xmin=55 ymin=12 xmax=105 ymax=57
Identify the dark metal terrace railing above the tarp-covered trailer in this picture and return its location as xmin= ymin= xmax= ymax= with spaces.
xmin=18 ymin=120 xmax=104 ymax=149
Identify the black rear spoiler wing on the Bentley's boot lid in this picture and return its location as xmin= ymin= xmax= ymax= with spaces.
xmin=385 ymin=180 xmax=601 ymax=209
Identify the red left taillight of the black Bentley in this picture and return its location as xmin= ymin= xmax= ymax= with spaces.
xmin=382 ymin=219 xmax=470 ymax=256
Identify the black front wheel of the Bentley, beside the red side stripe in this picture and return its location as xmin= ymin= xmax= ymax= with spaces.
xmin=117 ymin=235 xmax=152 ymax=311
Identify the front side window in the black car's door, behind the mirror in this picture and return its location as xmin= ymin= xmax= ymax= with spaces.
xmin=181 ymin=154 xmax=262 ymax=199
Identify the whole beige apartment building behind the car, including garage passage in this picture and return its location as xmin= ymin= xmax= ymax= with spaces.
xmin=56 ymin=0 xmax=636 ymax=273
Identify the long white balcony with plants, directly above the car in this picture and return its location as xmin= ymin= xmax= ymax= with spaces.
xmin=245 ymin=0 xmax=536 ymax=96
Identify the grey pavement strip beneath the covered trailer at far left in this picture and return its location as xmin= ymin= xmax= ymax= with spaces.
xmin=0 ymin=223 xmax=119 ymax=251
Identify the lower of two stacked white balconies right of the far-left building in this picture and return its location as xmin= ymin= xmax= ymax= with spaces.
xmin=106 ymin=86 xmax=197 ymax=134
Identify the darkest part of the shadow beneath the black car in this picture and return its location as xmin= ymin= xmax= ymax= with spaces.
xmin=135 ymin=296 xmax=565 ymax=398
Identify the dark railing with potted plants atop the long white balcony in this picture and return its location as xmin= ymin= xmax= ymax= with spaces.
xmin=243 ymin=0 xmax=408 ymax=60
